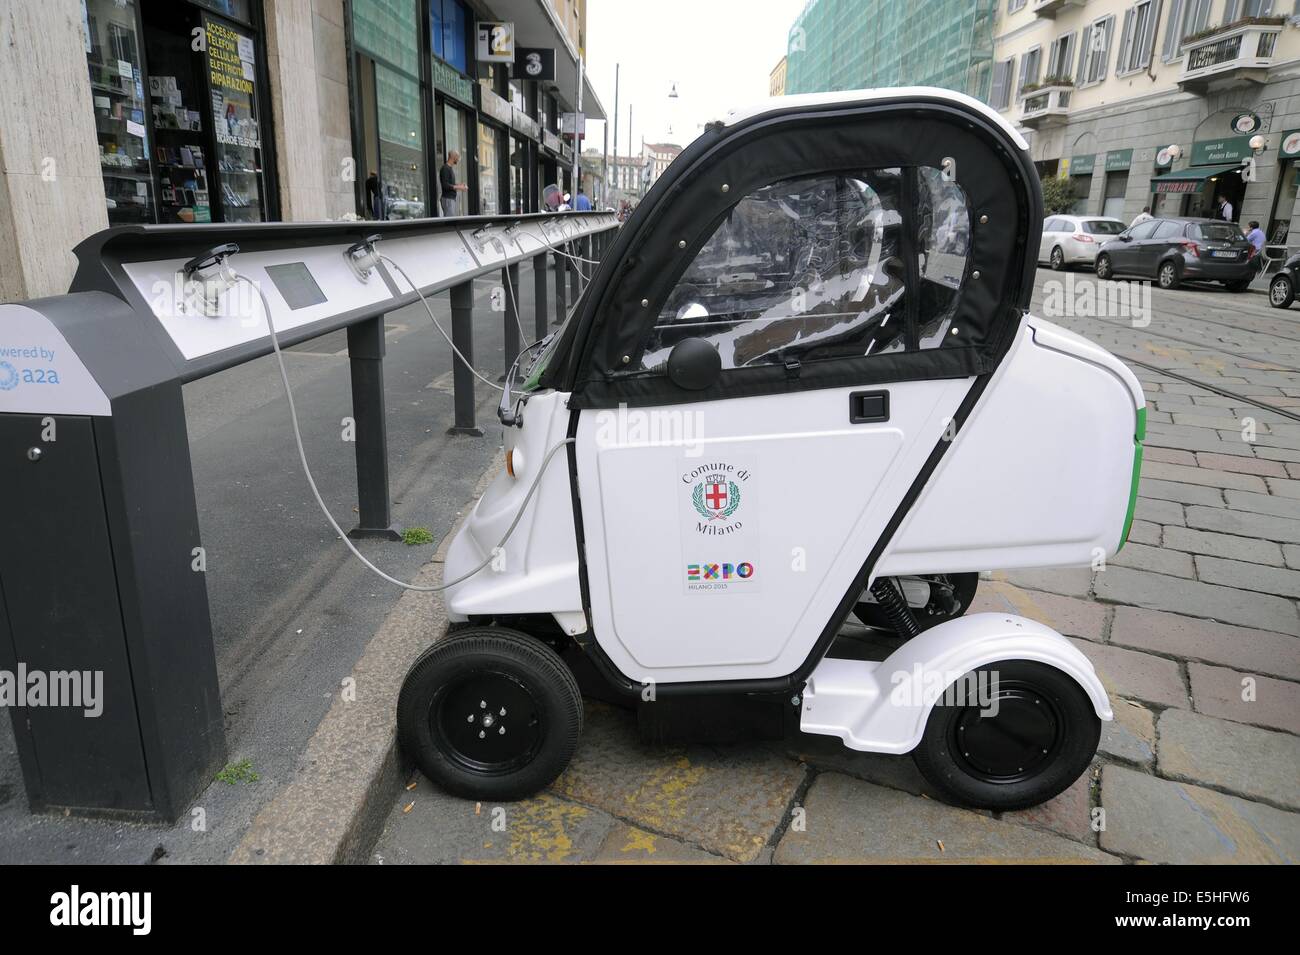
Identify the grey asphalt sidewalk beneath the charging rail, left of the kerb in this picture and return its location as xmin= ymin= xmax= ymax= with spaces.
xmin=0 ymin=257 xmax=569 ymax=863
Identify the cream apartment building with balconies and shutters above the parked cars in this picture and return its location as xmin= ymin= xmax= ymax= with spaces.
xmin=988 ymin=0 xmax=1300 ymax=249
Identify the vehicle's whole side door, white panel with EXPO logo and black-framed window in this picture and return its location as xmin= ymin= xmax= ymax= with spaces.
xmin=553 ymin=93 xmax=1043 ymax=685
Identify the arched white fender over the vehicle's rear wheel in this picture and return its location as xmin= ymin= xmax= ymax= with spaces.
xmin=800 ymin=613 xmax=1113 ymax=754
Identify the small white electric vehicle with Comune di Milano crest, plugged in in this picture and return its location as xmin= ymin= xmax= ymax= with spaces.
xmin=398 ymin=88 xmax=1145 ymax=809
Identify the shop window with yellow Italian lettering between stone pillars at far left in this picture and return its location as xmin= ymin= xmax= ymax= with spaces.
xmin=82 ymin=0 xmax=278 ymax=225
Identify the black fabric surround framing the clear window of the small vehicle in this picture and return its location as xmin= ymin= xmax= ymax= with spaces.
xmin=542 ymin=96 xmax=1043 ymax=408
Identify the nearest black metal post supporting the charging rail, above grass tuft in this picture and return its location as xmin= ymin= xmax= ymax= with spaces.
xmin=347 ymin=316 xmax=402 ymax=541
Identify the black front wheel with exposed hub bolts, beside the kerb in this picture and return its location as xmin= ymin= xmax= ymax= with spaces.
xmin=398 ymin=626 xmax=582 ymax=802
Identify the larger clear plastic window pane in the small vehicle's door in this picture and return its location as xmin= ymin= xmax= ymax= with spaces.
xmin=640 ymin=169 xmax=907 ymax=370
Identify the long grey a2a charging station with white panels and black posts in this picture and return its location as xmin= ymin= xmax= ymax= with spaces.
xmin=0 ymin=213 xmax=618 ymax=821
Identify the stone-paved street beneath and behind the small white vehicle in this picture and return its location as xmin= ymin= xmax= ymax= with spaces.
xmin=374 ymin=272 xmax=1300 ymax=863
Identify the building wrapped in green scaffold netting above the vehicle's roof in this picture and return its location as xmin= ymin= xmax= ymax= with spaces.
xmin=784 ymin=0 xmax=1006 ymax=99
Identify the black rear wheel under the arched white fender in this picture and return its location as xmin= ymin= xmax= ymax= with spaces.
xmin=911 ymin=660 xmax=1101 ymax=812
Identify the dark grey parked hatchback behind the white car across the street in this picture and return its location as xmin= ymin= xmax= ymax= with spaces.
xmin=1096 ymin=218 xmax=1258 ymax=292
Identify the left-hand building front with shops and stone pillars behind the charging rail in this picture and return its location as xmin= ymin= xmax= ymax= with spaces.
xmin=0 ymin=0 xmax=605 ymax=301
